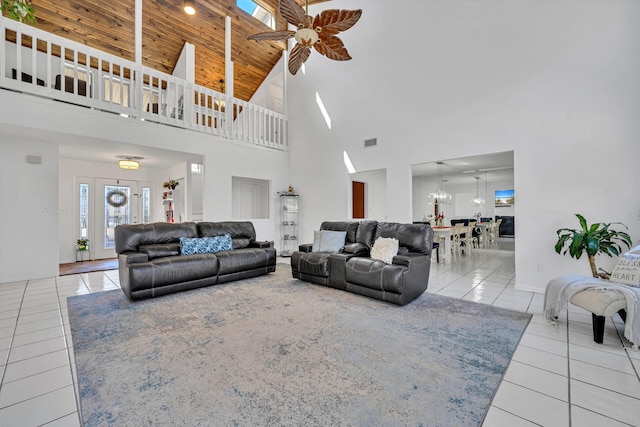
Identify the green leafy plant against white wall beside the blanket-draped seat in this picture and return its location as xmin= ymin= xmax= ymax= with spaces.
xmin=555 ymin=214 xmax=631 ymax=279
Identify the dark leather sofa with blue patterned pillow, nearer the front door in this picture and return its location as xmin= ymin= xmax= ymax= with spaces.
xmin=115 ymin=221 xmax=276 ymax=300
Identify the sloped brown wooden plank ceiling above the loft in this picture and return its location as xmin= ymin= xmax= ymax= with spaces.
xmin=20 ymin=0 xmax=326 ymax=101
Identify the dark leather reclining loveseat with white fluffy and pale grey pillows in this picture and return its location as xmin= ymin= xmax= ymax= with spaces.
xmin=291 ymin=221 xmax=433 ymax=305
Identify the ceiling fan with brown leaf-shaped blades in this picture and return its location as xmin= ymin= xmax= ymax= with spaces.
xmin=248 ymin=0 xmax=362 ymax=75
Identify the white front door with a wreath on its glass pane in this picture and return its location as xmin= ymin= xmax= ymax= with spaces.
xmin=91 ymin=178 xmax=140 ymax=259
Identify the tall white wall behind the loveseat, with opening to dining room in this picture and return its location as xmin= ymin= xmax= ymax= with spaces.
xmin=288 ymin=0 xmax=640 ymax=291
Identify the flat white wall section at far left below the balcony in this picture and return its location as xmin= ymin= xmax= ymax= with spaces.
xmin=0 ymin=139 xmax=58 ymax=283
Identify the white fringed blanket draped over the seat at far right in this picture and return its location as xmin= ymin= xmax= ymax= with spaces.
xmin=544 ymin=276 xmax=640 ymax=350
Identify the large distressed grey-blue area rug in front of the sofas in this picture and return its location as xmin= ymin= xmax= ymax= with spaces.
xmin=68 ymin=264 xmax=530 ymax=427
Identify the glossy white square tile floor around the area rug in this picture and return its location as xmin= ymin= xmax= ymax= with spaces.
xmin=0 ymin=241 xmax=640 ymax=427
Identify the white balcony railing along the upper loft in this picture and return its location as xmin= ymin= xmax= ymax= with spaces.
xmin=0 ymin=17 xmax=288 ymax=150
